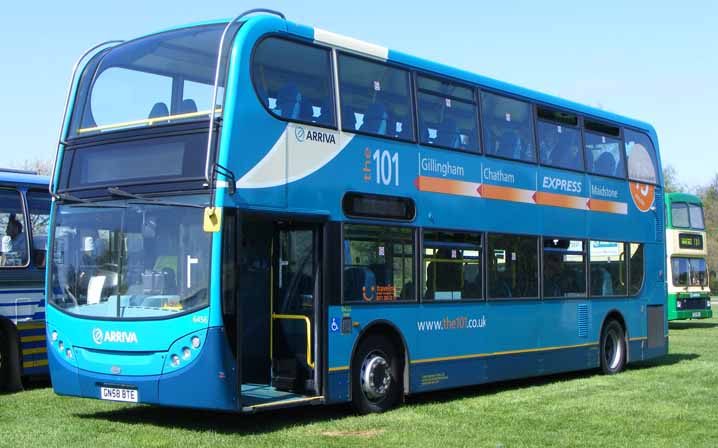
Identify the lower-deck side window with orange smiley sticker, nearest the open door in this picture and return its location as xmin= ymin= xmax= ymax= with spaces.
xmin=343 ymin=224 xmax=415 ymax=303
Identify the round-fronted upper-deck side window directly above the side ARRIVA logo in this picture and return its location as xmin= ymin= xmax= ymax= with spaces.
xmin=252 ymin=37 xmax=336 ymax=127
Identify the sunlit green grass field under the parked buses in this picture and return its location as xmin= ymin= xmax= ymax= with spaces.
xmin=0 ymin=319 xmax=718 ymax=448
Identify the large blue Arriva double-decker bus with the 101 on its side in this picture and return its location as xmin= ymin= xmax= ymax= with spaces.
xmin=47 ymin=11 xmax=668 ymax=413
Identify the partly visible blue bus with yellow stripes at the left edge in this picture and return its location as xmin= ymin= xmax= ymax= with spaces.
xmin=0 ymin=168 xmax=50 ymax=392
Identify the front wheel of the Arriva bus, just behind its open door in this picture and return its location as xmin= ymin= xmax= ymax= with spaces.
xmin=351 ymin=334 xmax=403 ymax=414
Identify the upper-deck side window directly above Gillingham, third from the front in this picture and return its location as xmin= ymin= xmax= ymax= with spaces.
xmin=416 ymin=76 xmax=479 ymax=152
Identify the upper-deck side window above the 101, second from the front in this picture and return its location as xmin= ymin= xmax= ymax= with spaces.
xmin=339 ymin=54 xmax=414 ymax=141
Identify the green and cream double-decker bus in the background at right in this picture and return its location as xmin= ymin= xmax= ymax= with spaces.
xmin=665 ymin=193 xmax=713 ymax=320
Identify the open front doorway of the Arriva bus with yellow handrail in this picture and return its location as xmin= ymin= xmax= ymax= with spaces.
xmin=224 ymin=215 xmax=322 ymax=412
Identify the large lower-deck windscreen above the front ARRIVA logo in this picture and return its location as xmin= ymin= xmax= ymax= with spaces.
xmin=49 ymin=202 xmax=210 ymax=319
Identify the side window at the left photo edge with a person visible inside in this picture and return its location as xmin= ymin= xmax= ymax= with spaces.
xmin=0 ymin=190 xmax=28 ymax=267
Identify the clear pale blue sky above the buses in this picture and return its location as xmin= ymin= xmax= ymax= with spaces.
xmin=0 ymin=0 xmax=718 ymax=188
